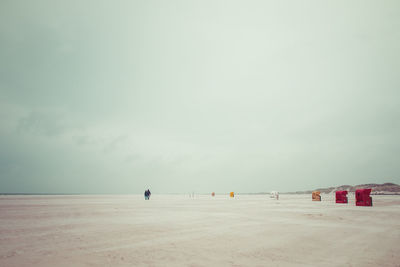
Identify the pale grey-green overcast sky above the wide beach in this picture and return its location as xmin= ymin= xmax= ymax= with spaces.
xmin=0 ymin=0 xmax=400 ymax=194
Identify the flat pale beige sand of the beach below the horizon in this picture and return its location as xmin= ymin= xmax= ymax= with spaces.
xmin=0 ymin=194 xmax=400 ymax=267
